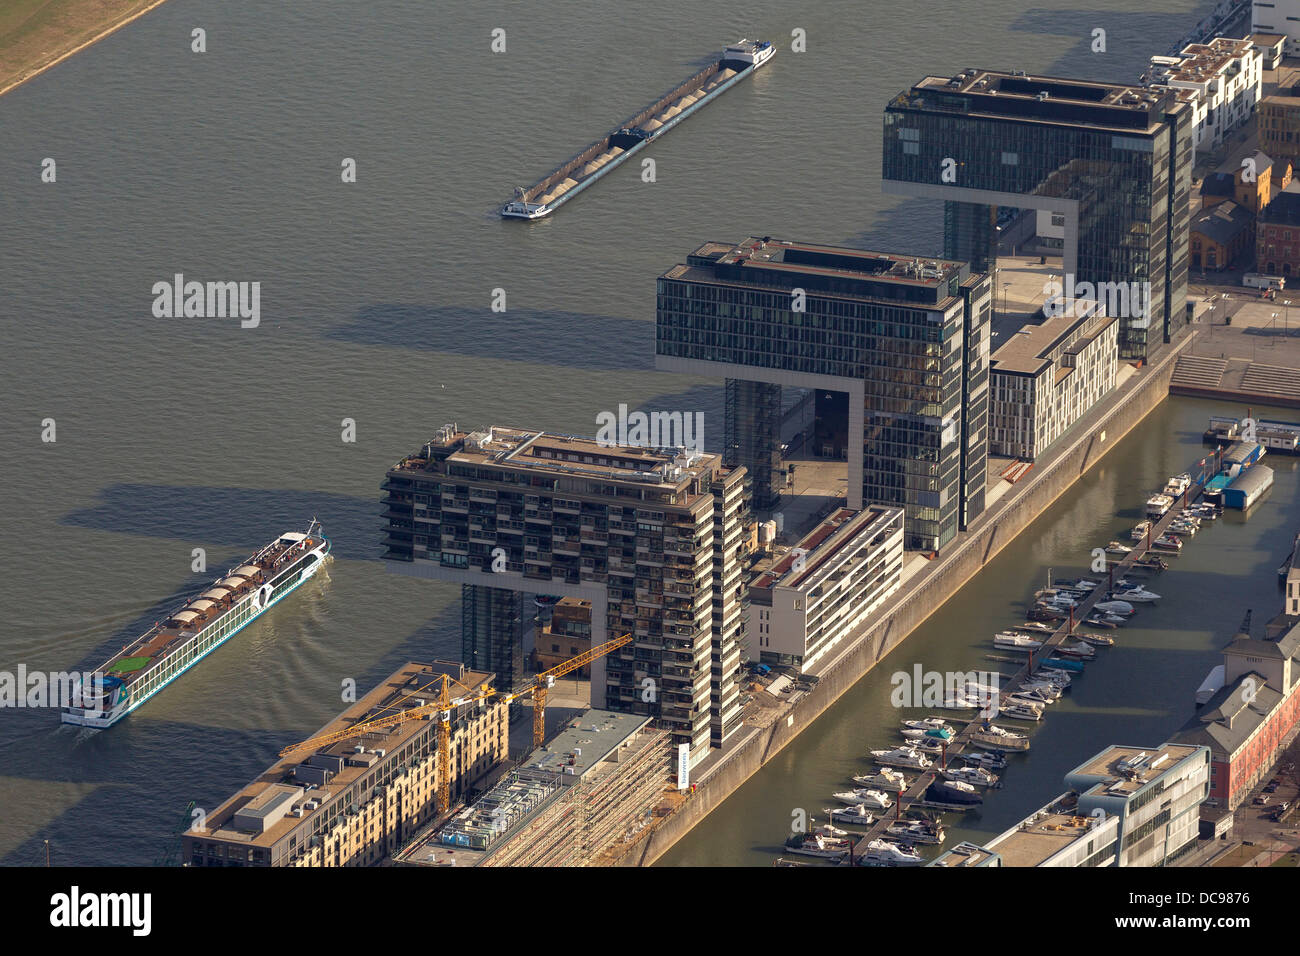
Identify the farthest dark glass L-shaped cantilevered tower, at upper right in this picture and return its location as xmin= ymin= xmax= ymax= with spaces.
xmin=881 ymin=69 xmax=1196 ymax=359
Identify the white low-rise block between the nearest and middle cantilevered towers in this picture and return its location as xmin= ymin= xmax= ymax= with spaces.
xmin=745 ymin=505 xmax=904 ymax=672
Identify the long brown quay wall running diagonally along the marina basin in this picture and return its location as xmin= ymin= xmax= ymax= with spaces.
xmin=619 ymin=336 xmax=1192 ymax=866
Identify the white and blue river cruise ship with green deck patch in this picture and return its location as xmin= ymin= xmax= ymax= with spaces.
xmin=61 ymin=519 xmax=330 ymax=730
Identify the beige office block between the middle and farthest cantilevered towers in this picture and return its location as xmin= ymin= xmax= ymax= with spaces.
xmin=988 ymin=300 xmax=1119 ymax=462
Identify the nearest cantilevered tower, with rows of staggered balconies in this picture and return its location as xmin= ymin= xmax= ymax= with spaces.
xmin=384 ymin=425 xmax=748 ymax=761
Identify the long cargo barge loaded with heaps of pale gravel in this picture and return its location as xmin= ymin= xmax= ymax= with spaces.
xmin=501 ymin=40 xmax=776 ymax=219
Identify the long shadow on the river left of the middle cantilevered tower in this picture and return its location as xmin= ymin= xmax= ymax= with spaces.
xmin=326 ymin=304 xmax=654 ymax=371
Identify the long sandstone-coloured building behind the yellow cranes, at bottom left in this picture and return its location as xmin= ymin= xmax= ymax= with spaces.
xmin=182 ymin=661 xmax=510 ymax=866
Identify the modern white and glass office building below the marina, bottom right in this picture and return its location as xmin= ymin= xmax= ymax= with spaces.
xmin=985 ymin=743 xmax=1209 ymax=868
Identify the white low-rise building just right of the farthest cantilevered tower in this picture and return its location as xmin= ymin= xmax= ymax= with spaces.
xmin=1143 ymin=37 xmax=1258 ymax=151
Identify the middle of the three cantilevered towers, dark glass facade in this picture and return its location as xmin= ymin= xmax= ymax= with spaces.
xmin=655 ymin=237 xmax=992 ymax=550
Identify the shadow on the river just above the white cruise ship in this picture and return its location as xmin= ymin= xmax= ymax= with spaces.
xmin=60 ymin=484 xmax=380 ymax=561
